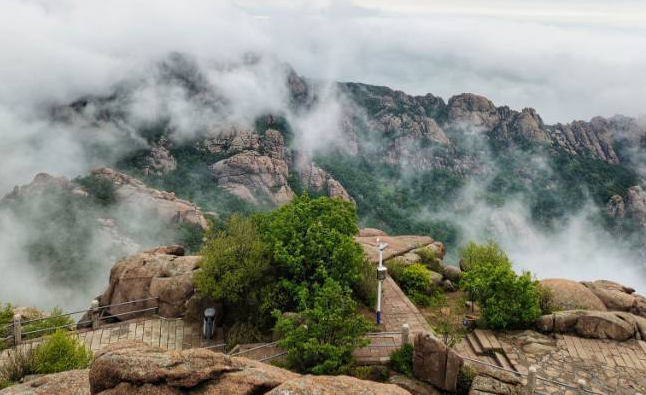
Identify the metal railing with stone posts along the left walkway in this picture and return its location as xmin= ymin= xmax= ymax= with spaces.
xmin=0 ymin=296 xmax=159 ymax=346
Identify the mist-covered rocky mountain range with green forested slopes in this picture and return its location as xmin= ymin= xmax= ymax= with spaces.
xmin=0 ymin=52 xmax=646 ymax=310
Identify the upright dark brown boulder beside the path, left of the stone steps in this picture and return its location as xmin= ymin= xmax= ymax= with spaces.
xmin=413 ymin=332 xmax=464 ymax=391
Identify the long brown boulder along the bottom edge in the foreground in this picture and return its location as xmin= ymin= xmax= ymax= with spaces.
xmin=89 ymin=341 xmax=408 ymax=395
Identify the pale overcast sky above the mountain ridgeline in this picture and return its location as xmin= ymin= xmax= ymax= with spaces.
xmin=0 ymin=0 xmax=646 ymax=123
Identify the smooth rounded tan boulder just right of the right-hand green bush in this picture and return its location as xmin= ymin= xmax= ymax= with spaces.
xmin=540 ymin=278 xmax=606 ymax=311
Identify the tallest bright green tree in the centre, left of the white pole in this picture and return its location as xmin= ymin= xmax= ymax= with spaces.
xmin=257 ymin=194 xmax=370 ymax=304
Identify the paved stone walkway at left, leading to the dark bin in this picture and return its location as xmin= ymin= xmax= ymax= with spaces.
xmin=0 ymin=318 xmax=224 ymax=360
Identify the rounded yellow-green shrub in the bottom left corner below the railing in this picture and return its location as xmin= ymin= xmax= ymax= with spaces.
xmin=32 ymin=331 xmax=92 ymax=374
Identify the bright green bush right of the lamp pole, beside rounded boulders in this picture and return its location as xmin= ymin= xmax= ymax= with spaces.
xmin=460 ymin=242 xmax=541 ymax=329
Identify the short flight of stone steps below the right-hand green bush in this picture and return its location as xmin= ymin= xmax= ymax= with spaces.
xmin=455 ymin=329 xmax=514 ymax=369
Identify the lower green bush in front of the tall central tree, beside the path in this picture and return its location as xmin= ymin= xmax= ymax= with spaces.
xmin=275 ymin=279 xmax=371 ymax=375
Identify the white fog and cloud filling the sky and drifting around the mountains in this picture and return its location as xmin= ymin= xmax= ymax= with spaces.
xmin=0 ymin=0 xmax=646 ymax=307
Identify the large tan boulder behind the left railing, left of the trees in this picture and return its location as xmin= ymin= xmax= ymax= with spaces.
xmin=99 ymin=251 xmax=216 ymax=320
